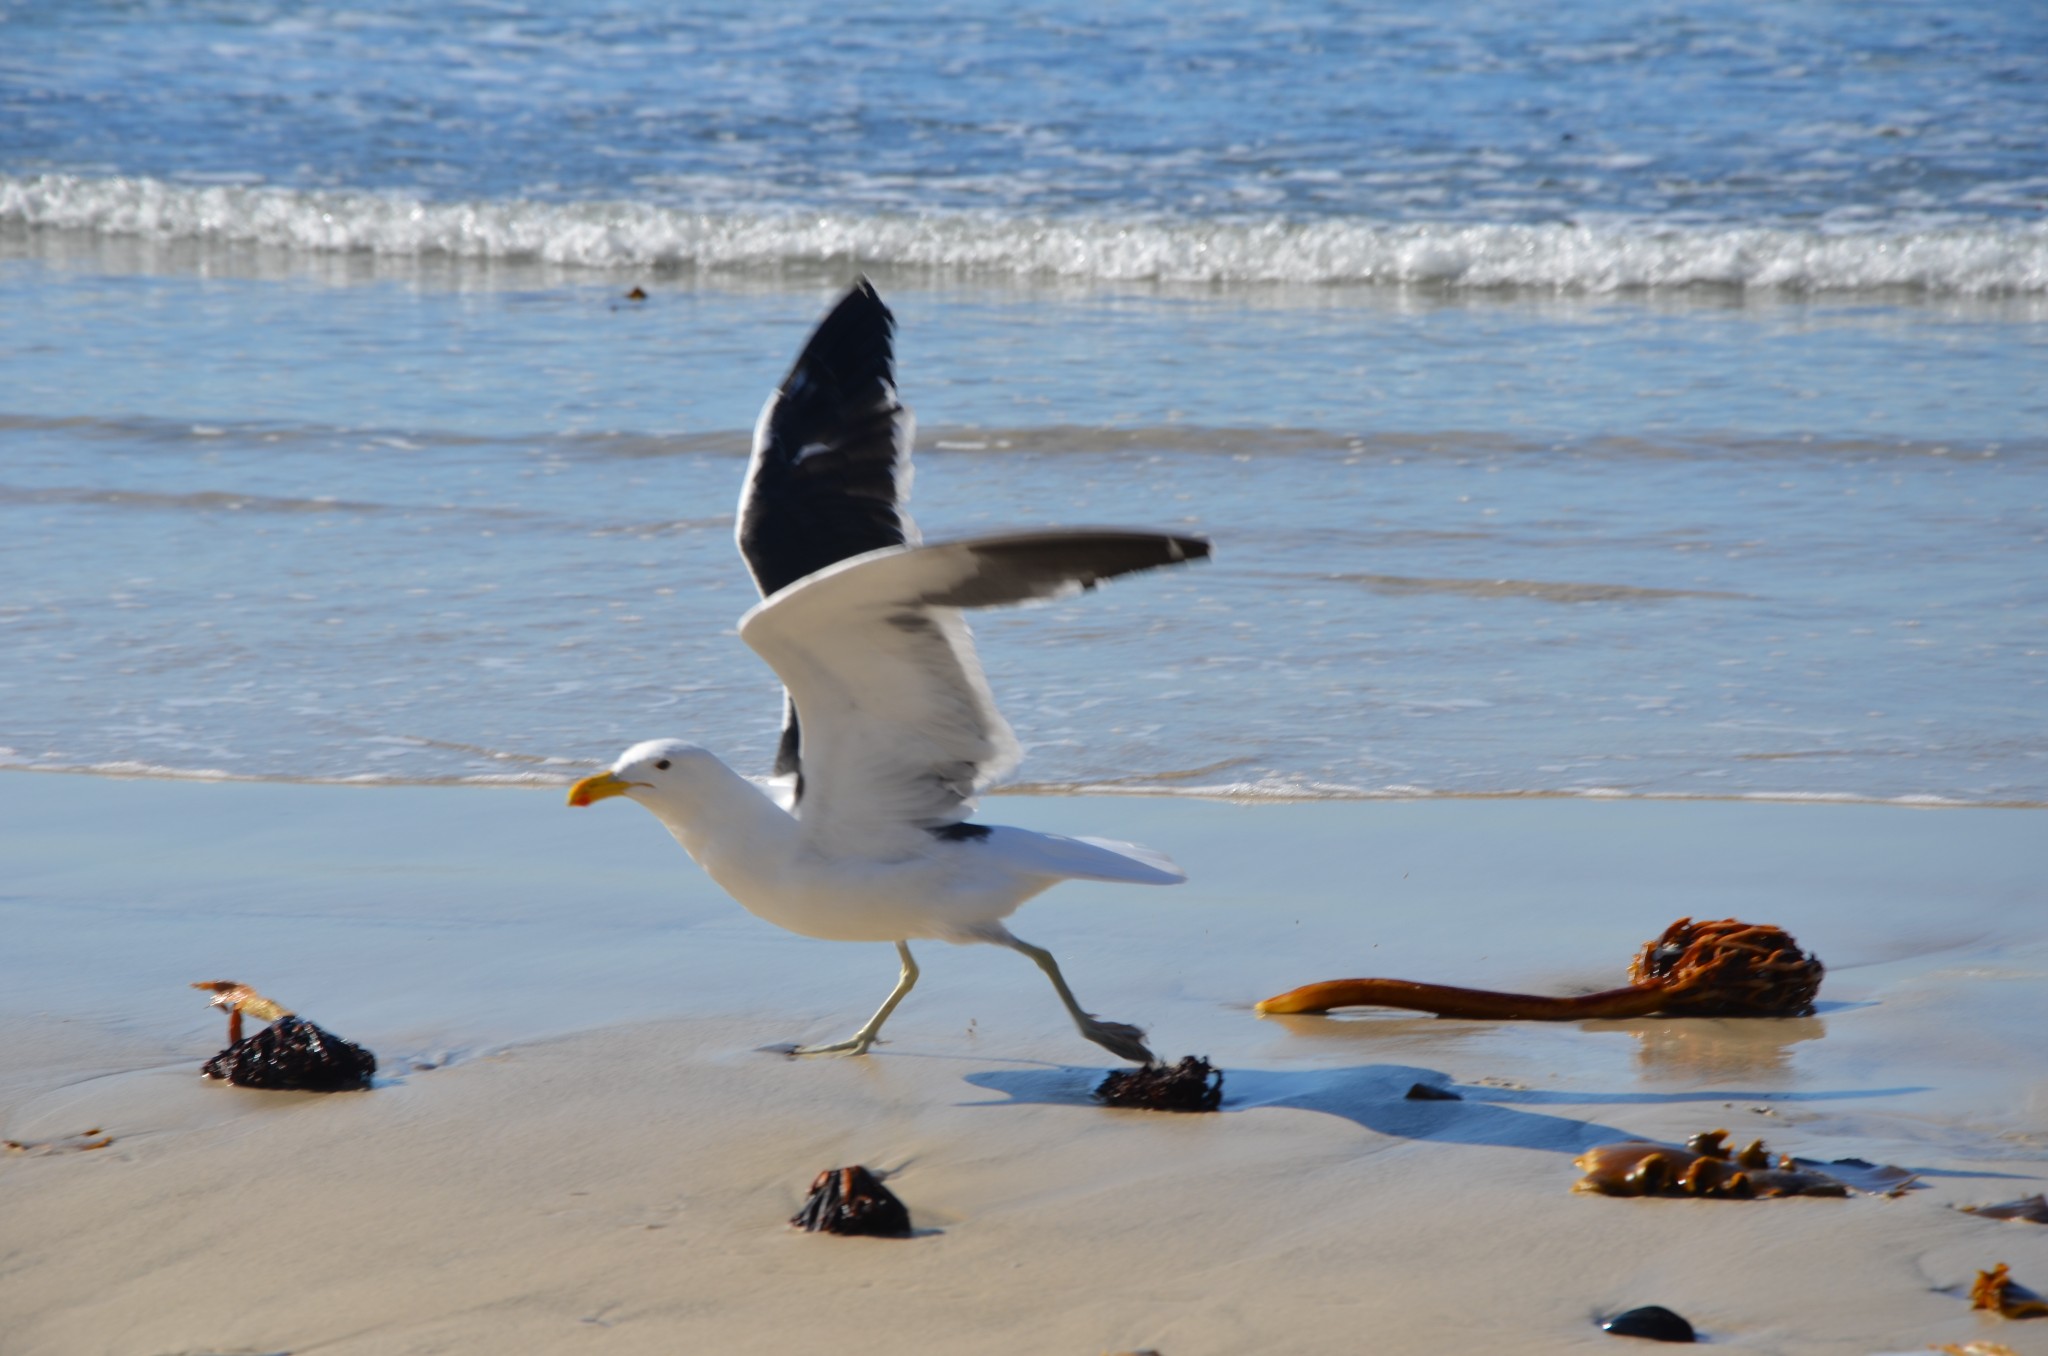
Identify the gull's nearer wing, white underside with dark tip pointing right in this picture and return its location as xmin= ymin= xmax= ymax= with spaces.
xmin=739 ymin=528 xmax=1208 ymax=858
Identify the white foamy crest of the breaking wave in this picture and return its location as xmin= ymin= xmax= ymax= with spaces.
xmin=0 ymin=174 xmax=2048 ymax=295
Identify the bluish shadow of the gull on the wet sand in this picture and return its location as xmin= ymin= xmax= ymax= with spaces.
xmin=963 ymin=1063 xmax=1925 ymax=1155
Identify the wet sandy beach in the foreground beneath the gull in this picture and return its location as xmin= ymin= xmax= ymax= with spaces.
xmin=0 ymin=774 xmax=2048 ymax=1356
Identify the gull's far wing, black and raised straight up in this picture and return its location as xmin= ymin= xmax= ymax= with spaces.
xmin=737 ymin=279 xmax=918 ymax=772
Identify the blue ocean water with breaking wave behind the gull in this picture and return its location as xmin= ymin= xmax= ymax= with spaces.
xmin=0 ymin=0 xmax=2048 ymax=805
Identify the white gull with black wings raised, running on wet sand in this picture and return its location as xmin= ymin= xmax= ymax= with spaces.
xmin=569 ymin=279 xmax=1208 ymax=1065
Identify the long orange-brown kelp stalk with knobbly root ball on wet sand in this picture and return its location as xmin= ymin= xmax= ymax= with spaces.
xmin=1257 ymin=918 xmax=1827 ymax=1022
